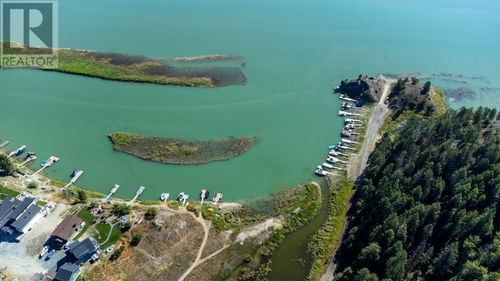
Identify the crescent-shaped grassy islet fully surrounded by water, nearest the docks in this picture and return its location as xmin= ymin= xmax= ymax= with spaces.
xmin=108 ymin=132 xmax=256 ymax=164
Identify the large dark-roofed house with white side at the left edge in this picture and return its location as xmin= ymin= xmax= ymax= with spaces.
xmin=0 ymin=196 xmax=42 ymax=234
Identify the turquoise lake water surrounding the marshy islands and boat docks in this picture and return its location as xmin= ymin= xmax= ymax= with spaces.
xmin=0 ymin=0 xmax=500 ymax=200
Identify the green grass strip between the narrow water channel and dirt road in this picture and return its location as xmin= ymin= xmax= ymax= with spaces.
xmin=307 ymin=179 xmax=354 ymax=280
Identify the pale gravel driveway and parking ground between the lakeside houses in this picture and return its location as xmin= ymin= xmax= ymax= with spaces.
xmin=0 ymin=204 xmax=69 ymax=280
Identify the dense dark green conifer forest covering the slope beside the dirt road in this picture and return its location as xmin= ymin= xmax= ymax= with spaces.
xmin=335 ymin=107 xmax=500 ymax=281
